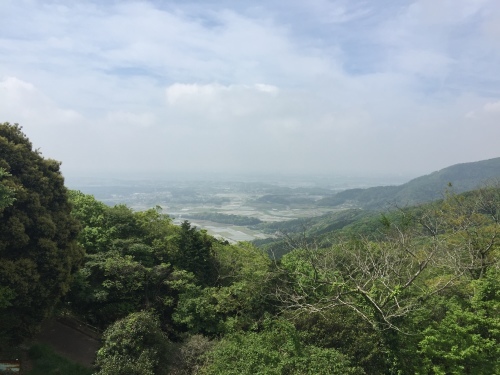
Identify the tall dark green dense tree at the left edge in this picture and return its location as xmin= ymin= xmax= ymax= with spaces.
xmin=0 ymin=123 xmax=83 ymax=341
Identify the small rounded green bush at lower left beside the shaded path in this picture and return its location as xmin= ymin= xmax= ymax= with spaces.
xmin=96 ymin=311 xmax=170 ymax=375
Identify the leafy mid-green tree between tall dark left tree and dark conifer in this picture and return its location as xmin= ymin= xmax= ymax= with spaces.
xmin=66 ymin=197 xmax=179 ymax=327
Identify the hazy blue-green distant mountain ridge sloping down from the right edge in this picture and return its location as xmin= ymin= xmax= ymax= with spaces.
xmin=318 ymin=157 xmax=500 ymax=209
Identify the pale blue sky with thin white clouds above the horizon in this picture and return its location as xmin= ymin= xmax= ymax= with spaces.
xmin=0 ymin=0 xmax=500 ymax=179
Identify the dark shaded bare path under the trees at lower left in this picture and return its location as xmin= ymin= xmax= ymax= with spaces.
xmin=35 ymin=319 xmax=101 ymax=367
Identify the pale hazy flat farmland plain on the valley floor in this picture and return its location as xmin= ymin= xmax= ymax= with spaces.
xmin=68 ymin=177 xmax=410 ymax=242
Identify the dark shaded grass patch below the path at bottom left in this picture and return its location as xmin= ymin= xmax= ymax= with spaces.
xmin=28 ymin=344 xmax=93 ymax=375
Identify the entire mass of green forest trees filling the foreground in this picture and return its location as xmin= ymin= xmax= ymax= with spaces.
xmin=0 ymin=124 xmax=500 ymax=375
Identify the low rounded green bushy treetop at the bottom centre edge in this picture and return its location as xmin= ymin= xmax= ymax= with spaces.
xmin=201 ymin=320 xmax=364 ymax=375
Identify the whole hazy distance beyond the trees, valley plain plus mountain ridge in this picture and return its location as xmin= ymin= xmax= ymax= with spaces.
xmin=68 ymin=158 xmax=500 ymax=243
